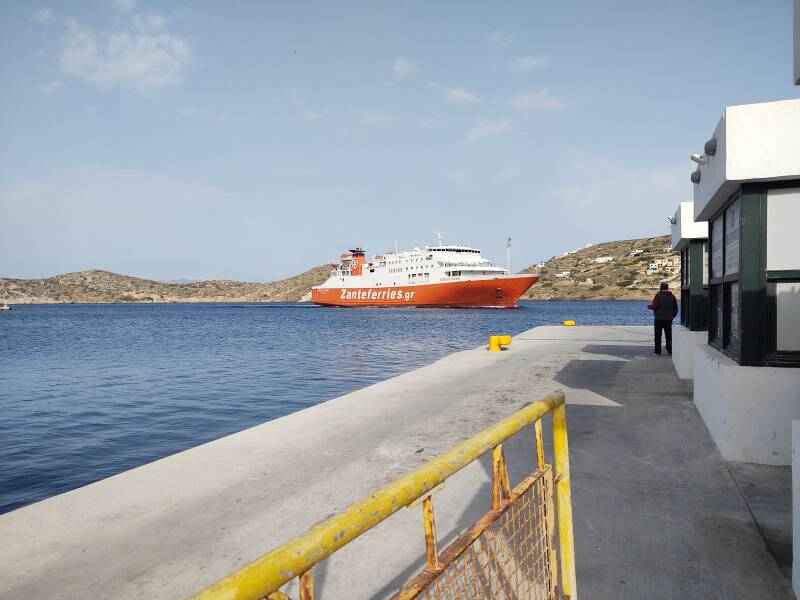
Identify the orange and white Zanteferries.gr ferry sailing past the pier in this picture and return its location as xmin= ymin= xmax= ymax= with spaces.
xmin=311 ymin=232 xmax=539 ymax=308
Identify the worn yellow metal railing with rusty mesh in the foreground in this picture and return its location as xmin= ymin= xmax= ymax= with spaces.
xmin=193 ymin=391 xmax=577 ymax=600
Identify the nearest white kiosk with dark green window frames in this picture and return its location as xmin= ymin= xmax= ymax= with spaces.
xmin=691 ymin=100 xmax=800 ymax=465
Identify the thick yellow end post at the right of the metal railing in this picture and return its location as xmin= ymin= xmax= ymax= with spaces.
xmin=553 ymin=403 xmax=578 ymax=600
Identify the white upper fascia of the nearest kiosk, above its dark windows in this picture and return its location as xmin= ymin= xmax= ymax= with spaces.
xmin=694 ymin=100 xmax=800 ymax=221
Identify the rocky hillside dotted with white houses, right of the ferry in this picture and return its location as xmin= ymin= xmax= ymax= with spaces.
xmin=523 ymin=235 xmax=680 ymax=300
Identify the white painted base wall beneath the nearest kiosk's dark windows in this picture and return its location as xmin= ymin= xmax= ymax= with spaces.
xmin=694 ymin=345 xmax=800 ymax=465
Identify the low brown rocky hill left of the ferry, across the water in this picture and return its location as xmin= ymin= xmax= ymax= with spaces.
xmin=0 ymin=265 xmax=332 ymax=304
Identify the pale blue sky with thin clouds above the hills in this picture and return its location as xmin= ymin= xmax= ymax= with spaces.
xmin=0 ymin=0 xmax=800 ymax=281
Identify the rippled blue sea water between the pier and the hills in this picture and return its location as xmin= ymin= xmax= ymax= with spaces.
xmin=0 ymin=302 xmax=652 ymax=513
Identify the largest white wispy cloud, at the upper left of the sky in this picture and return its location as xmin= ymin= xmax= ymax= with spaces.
xmin=59 ymin=20 xmax=192 ymax=92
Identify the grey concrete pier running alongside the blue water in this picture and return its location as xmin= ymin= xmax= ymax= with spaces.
xmin=0 ymin=327 xmax=791 ymax=600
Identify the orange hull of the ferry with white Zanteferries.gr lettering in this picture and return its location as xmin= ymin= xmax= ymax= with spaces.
xmin=311 ymin=275 xmax=539 ymax=308
